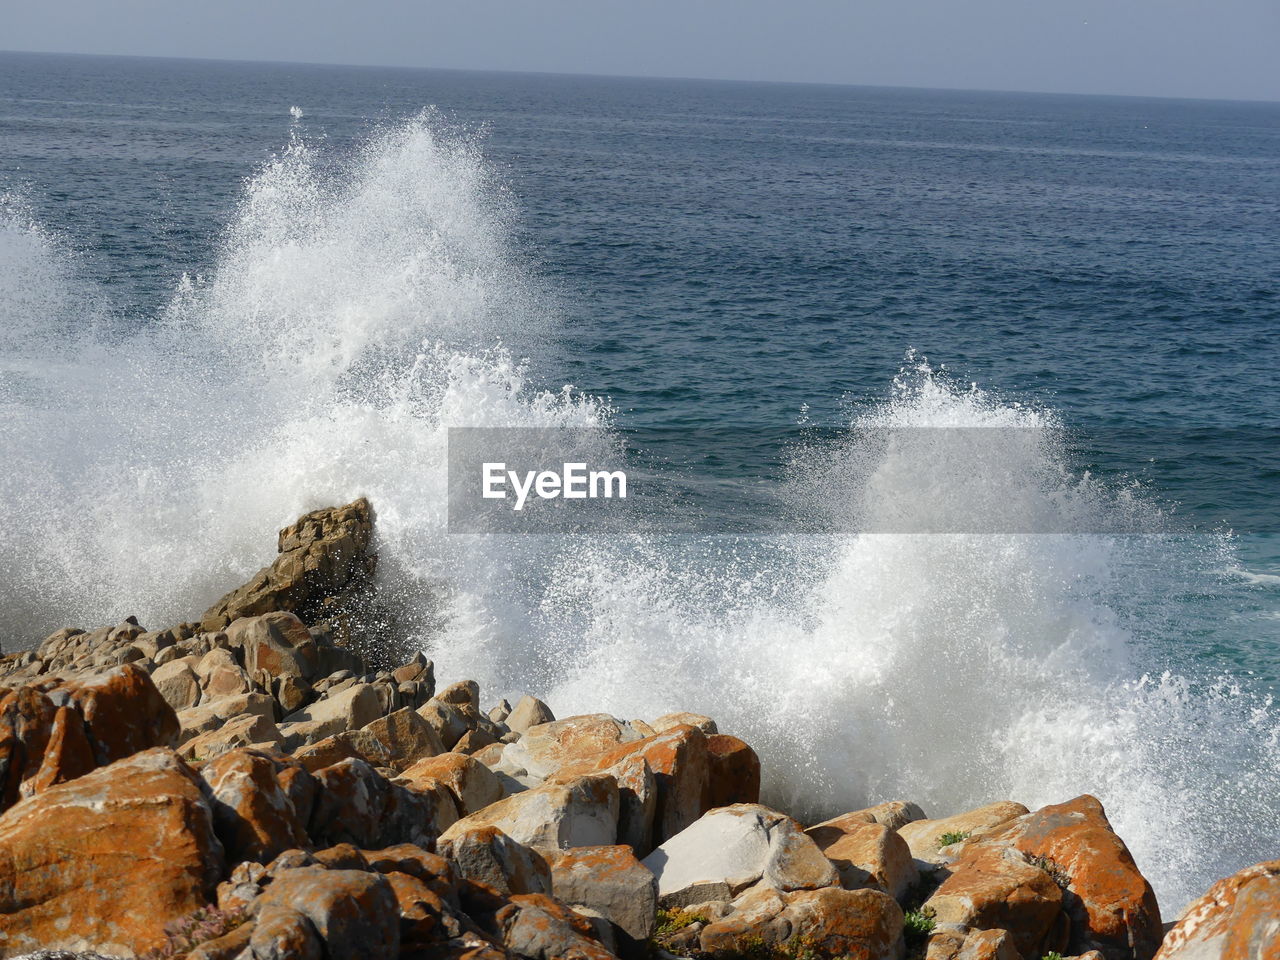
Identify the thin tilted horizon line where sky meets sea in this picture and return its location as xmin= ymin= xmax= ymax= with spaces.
xmin=0 ymin=49 xmax=1280 ymax=104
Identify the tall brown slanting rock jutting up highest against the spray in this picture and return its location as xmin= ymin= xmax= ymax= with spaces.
xmin=200 ymin=498 xmax=378 ymax=640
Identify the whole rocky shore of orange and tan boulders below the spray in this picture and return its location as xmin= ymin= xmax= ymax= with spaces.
xmin=0 ymin=500 xmax=1280 ymax=960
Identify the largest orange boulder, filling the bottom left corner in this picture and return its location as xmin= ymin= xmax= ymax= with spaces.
xmin=0 ymin=747 xmax=223 ymax=955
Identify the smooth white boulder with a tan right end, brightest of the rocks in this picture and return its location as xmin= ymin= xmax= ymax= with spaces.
xmin=644 ymin=804 xmax=840 ymax=908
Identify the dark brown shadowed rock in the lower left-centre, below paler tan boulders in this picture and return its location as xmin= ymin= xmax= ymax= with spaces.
xmin=308 ymin=760 xmax=458 ymax=850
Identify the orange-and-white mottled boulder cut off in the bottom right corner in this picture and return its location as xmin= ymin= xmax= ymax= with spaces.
xmin=1156 ymin=860 xmax=1280 ymax=960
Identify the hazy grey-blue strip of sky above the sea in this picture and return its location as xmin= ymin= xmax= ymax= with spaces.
xmin=0 ymin=0 xmax=1280 ymax=100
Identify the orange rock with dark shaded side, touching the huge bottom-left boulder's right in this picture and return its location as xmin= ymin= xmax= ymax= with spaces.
xmin=202 ymin=750 xmax=310 ymax=864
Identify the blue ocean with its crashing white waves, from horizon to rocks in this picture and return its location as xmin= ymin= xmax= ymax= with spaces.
xmin=0 ymin=54 xmax=1280 ymax=916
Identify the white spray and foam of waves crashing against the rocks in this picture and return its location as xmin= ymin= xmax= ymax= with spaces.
xmin=0 ymin=111 xmax=1280 ymax=919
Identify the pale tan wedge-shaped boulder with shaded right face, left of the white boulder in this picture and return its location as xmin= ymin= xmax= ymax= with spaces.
xmin=442 ymin=774 xmax=618 ymax=847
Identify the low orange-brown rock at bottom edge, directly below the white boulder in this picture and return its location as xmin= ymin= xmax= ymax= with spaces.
xmin=699 ymin=887 xmax=905 ymax=960
